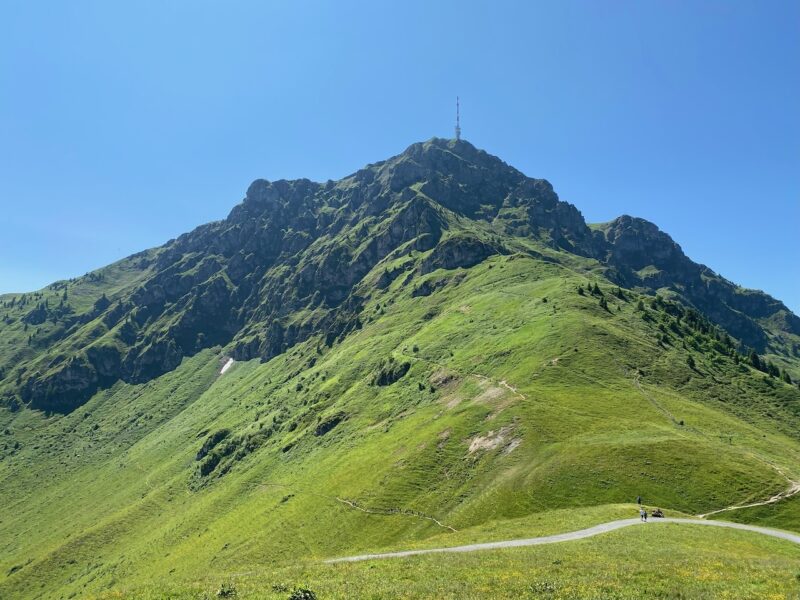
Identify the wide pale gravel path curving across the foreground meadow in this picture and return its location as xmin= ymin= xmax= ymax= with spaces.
xmin=325 ymin=518 xmax=800 ymax=563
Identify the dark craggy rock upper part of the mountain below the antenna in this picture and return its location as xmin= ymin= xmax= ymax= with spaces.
xmin=0 ymin=139 xmax=800 ymax=411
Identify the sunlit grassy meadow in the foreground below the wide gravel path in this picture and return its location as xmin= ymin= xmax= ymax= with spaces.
xmin=98 ymin=508 xmax=800 ymax=599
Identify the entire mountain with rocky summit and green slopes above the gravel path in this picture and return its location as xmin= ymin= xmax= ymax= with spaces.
xmin=0 ymin=139 xmax=800 ymax=597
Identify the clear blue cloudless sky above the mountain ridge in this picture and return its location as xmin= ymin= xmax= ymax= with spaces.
xmin=0 ymin=0 xmax=800 ymax=312
